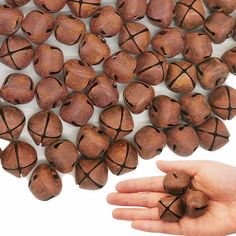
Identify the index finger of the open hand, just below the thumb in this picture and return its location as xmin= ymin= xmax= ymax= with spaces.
xmin=116 ymin=176 xmax=164 ymax=193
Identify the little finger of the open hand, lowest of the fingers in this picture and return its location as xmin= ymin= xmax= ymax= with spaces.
xmin=132 ymin=220 xmax=182 ymax=235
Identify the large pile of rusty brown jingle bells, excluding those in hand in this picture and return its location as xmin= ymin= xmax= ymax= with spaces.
xmin=0 ymin=0 xmax=236 ymax=200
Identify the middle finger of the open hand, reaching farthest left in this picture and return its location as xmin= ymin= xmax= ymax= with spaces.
xmin=107 ymin=193 xmax=166 ymax=208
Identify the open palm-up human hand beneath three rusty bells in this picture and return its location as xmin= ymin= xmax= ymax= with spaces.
xmin=107 ymin=161 xmax=236 ymax=236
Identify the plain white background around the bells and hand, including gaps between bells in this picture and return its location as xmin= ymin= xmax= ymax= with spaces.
xmin=0 ymin=0 xmax=236 ymax=236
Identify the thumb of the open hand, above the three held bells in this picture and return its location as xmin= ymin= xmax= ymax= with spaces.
xmin=157 ymin=161 xmax=203 ymax=176
